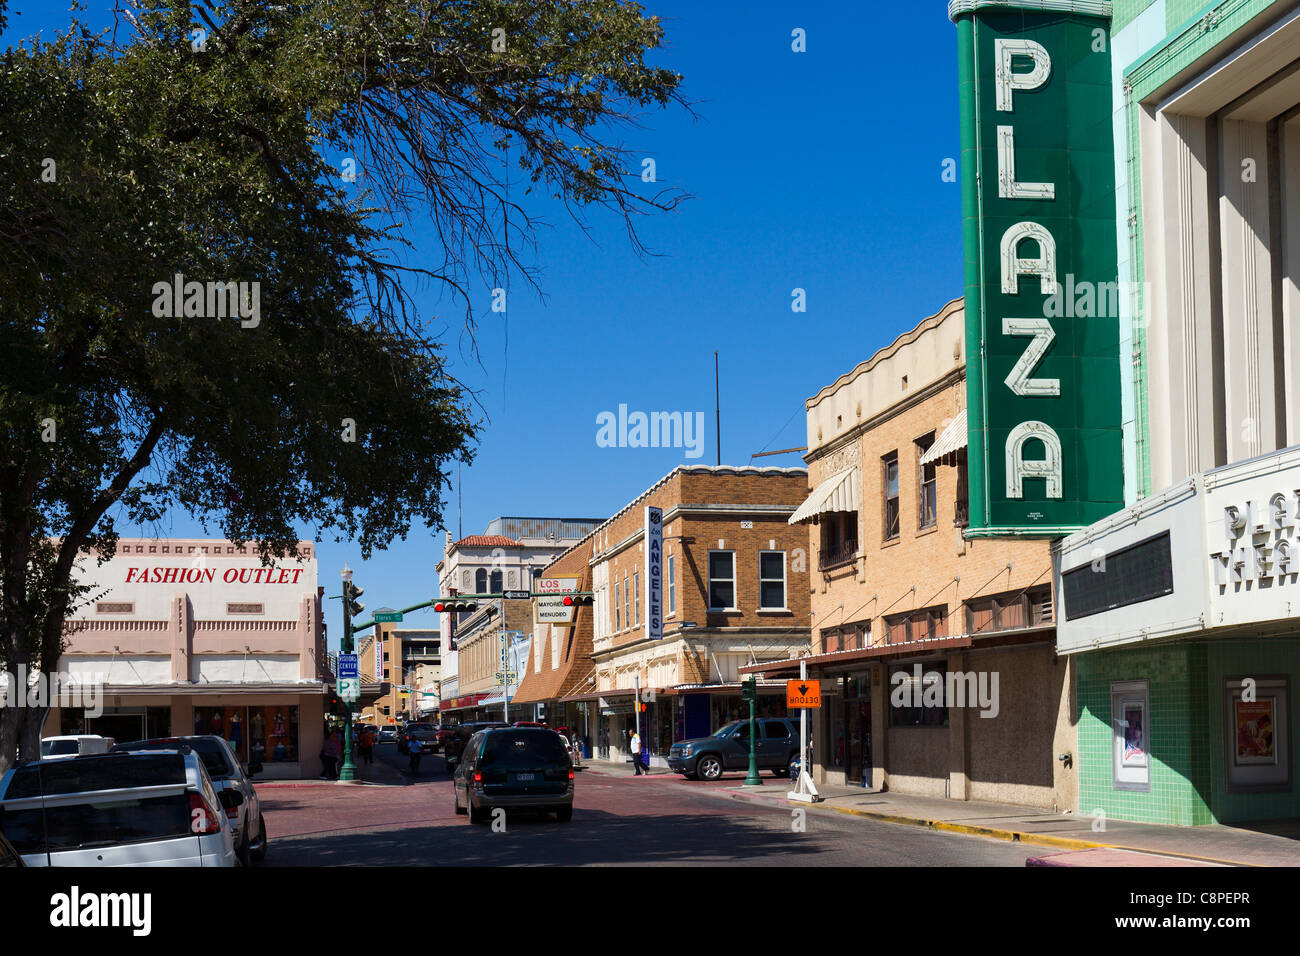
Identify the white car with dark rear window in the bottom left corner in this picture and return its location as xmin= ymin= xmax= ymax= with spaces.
xmin=0 ymin=747 xmax=239 ymax=868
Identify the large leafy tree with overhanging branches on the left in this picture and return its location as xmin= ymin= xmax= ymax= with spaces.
xmin=0 ymin=0 xmax=684 ymax=771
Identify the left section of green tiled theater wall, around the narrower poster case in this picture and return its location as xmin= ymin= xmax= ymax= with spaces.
xmin=1078 ymin=644 xmax=1214 ymax=826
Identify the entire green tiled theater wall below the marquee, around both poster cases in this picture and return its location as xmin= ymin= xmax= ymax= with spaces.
xmin=1078 ymin=639 xmax=1300 ymax=826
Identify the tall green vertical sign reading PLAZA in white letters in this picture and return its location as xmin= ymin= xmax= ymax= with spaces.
xmin=948 ymin=0 xmax=1123 ymax=536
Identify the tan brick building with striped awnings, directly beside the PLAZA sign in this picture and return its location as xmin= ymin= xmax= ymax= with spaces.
xmin=741 ymin=299 xmax=1075 ymax=808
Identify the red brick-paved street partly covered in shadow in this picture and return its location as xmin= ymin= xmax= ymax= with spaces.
xmin=259 ymin=744 xmax=1049 ymax=866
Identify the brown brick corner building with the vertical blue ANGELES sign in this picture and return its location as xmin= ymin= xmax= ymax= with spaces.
xmin=525 ymin=466 xmax=809 ymax=758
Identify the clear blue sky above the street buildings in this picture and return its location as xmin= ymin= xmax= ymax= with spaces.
xmin=3 ymin=0 xmax=962 ymax=644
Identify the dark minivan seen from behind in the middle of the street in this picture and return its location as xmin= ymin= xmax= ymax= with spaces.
xmin=451 ymin=727 xmax=573 ymax=823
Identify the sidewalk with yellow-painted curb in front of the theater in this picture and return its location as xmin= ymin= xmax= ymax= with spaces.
xmin=585 ymin=760 xmax=1300 ymax=866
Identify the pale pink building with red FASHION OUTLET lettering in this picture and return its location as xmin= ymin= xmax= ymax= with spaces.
xmin=43 ymin=538 xmax=329 ymax=779
